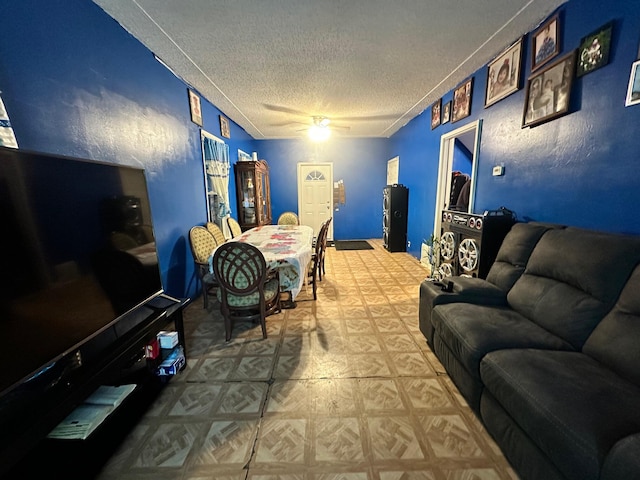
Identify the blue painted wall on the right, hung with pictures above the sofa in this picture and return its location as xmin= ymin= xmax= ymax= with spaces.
xmin=391 ymin=0 xmax=640 ymax=257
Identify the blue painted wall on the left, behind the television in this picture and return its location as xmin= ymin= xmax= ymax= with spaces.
xmin=0 ymin=0 xmax=254 ymax=296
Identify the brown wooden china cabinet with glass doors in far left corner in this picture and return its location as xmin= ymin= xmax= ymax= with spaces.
xmin=234 ymin=160 xmax=271 ymax=231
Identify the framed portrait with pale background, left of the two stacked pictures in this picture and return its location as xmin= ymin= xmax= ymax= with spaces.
xmin=484 ymin=38 xmax=522 ymax=108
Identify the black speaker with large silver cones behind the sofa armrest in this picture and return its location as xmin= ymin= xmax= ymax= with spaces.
xmin=439 ymin=208 xmax=515 ymax=278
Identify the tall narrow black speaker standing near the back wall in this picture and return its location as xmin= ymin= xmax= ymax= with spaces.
xmin=382 ymin=184 xmax=409 ymax=252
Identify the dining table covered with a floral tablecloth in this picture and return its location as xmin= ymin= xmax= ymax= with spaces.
xmin=231 ymin=225 xmax=313 ymax=308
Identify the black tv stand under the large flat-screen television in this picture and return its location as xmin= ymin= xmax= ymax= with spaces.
xmin=0 ymin=294 xmax=189 ymax=479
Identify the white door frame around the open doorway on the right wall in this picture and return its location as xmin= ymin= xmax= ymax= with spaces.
xmin=433 ymin=119 xmax=482 ymax=237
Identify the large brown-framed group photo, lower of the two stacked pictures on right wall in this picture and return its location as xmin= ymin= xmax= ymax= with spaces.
xmin=522 ymin=50 xmax=576 ymax=127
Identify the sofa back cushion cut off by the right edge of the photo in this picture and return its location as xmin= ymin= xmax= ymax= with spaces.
xmin=582 ymin=266 xmax=640 ymax=386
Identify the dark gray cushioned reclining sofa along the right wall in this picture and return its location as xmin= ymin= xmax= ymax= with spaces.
xmin=419 ymin=223 xmax=640 ymax=480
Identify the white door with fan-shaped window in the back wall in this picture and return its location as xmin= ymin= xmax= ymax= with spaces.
xmin=298 ymin=163 xmax=333 ymax=240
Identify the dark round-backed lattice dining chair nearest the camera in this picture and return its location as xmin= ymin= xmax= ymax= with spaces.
xmin=213 ymin=241 xmax=281 ymax=342
